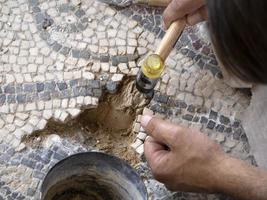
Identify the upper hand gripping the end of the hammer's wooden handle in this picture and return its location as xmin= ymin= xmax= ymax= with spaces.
xmin=163 ymin=0 xmax=208 ymax=28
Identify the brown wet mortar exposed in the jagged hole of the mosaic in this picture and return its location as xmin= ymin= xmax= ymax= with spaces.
xmin=23 ymin=78 xmax=149 ymax=166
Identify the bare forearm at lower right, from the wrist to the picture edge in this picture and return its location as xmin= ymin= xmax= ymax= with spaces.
xmin=216 ymin=157 xmax=267 ymax=200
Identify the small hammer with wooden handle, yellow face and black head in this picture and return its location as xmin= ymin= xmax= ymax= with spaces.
xmin=136 ymin=18 xmax=186 ymax=94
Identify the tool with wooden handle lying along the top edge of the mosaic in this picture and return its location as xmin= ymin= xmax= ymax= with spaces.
xmin=98 ymin=0 xmax=171 ymax=7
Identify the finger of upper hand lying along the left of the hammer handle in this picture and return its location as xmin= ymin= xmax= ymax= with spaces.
xmin=163 ymin=0 xmax=205 ymax=28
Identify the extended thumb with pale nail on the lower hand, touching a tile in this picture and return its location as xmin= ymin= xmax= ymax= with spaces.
xmin=141 ymin=115 xmax=182 ymax=149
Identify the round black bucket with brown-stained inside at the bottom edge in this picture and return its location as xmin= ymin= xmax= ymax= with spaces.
xmin=41 ymin=152 xmax=148 ymax=200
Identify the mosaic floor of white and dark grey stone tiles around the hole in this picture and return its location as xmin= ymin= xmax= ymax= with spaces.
xmin=0 ymin=0 xmax=256 ymax=200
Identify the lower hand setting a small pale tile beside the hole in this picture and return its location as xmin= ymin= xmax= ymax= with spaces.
xmin=141 ymin=115 xmax=228 ymax=192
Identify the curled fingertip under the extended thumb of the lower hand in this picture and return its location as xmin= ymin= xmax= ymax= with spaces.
xmin=144 ymin=136 xmax=169 ymax=168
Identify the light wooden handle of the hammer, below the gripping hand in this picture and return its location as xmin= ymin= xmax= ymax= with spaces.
xmin=155 ymin=19 xmax=186 ymax=61
